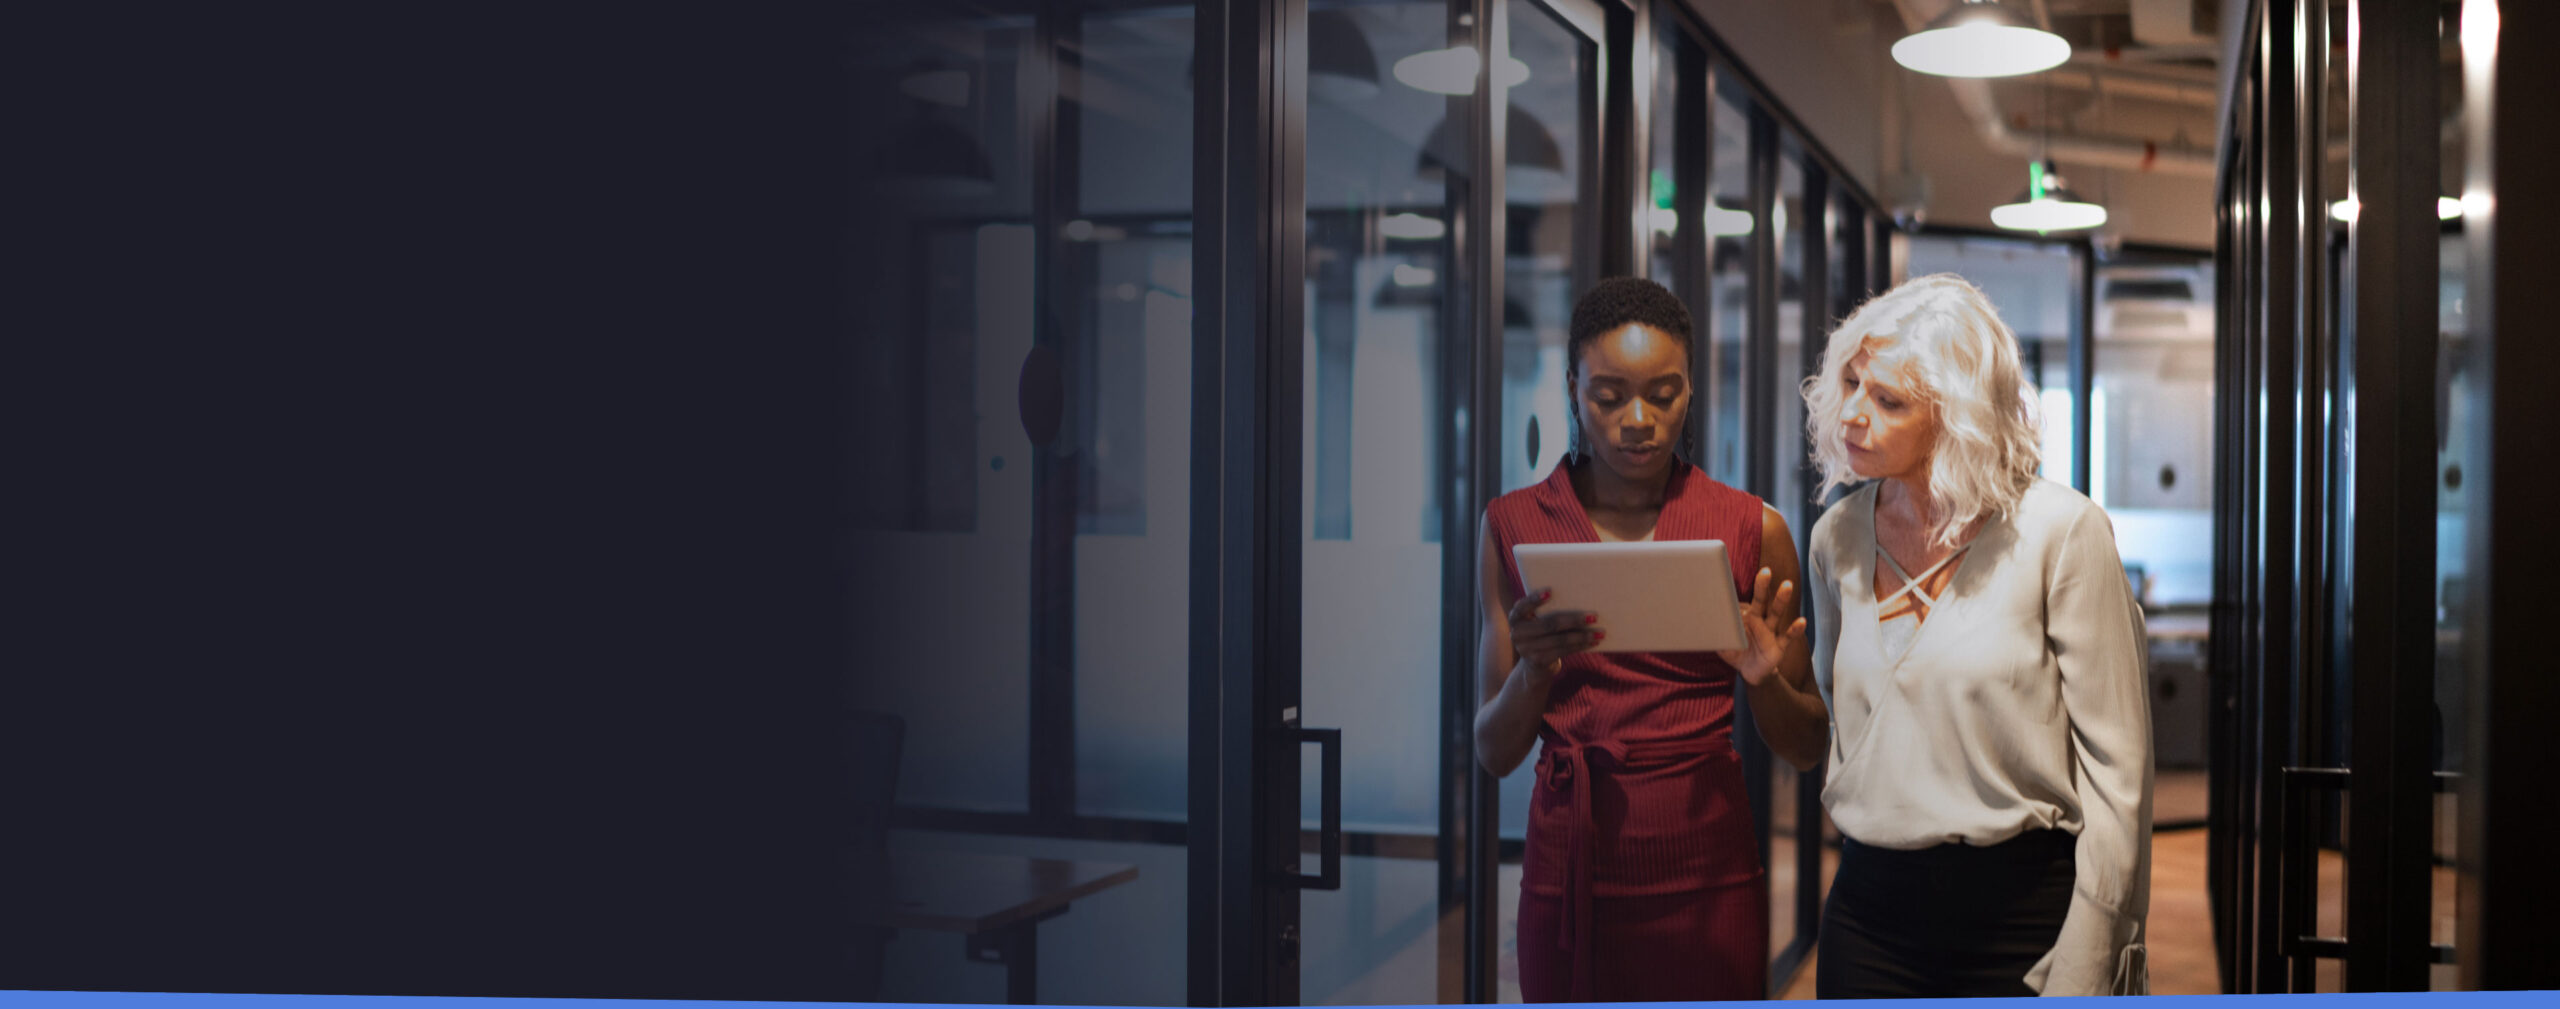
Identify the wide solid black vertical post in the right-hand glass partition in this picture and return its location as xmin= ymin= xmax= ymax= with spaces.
xmin=2344 ymin=0 xmax=2442 ymax=991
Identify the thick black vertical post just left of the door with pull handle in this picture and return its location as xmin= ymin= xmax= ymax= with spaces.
xmin=1185 ymin=0 xmax=1306 ymax=1006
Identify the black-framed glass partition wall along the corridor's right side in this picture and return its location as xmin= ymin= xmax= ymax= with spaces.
xmin=2211 ymin=0 xmax=2560 ymax=991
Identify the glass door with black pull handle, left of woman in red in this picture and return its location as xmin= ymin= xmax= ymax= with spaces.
xmin=1272 ymin=0 xmax=1482 ymax=1004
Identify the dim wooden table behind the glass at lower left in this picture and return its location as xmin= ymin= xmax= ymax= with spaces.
xmin=858 ymin=850 xmax=1137 ymax=1004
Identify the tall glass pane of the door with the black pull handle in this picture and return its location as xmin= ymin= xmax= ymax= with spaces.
xmin=1298 ymin=3 xmax=1475 ymax=1004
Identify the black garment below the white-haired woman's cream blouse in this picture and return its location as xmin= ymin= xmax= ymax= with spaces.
xmin=1812 ymin=830 xmax=2079 ymax=999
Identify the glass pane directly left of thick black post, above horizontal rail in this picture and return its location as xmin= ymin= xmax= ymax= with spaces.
xmin=1057 ymin=10 xmax=1190 ymax=829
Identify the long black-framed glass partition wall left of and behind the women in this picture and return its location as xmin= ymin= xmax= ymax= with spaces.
xmin=847 ymin=0 xmax=1889 ymax=1004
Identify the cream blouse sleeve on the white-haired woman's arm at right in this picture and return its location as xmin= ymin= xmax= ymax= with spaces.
xmin=2025 ymin=507 xmax=2150 ymax=996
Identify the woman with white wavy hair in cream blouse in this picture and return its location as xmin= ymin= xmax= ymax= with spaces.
xmin=1805 ymin=274 xmax=2150 ymax=999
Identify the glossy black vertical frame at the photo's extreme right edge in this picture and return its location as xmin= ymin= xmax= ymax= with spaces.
xmin=2455 ymin=0 xmax=2560 ymax=991
